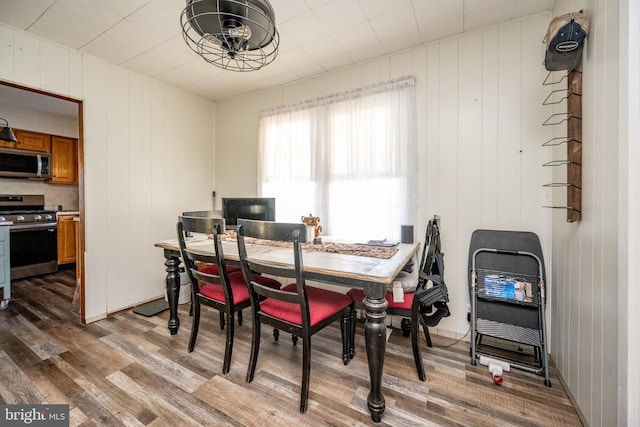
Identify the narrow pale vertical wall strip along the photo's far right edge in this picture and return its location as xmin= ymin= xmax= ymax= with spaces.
xmin=618 ymin=0 xmax=640 ymax=426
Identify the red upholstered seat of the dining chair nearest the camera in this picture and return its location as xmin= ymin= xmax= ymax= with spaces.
xmin=260 ymin=283 xmax=353 ymax=326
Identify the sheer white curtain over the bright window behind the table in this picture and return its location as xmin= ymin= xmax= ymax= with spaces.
xmin=258 ymin=77 xmax=418 ymax=241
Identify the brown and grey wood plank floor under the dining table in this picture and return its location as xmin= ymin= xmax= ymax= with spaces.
xmin=0 ymin=272 xmax=581 ymax=426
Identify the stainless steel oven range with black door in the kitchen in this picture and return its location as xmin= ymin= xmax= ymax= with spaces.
xmin=0 ymin=195 xmax=58 ymax=280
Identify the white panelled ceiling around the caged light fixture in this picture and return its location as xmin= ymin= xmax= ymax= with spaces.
xmin=0 ymin=0 xmax=555 ymax=100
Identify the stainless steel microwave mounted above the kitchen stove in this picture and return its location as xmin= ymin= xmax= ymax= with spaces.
xmin=0 ymin=148 xmax=51 ymax=179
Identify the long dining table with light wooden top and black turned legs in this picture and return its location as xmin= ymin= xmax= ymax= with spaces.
xmin=155 ymin=236 xmax=419 ymax=422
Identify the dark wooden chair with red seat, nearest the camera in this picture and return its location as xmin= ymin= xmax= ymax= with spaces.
xmin=236 ymin=219 xmax=355 ymax=413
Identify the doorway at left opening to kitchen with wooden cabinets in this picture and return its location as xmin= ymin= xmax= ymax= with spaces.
xmin=0 ymin=81 xmax=85 ymax=323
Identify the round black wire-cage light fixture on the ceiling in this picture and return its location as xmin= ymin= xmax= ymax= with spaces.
xmin=180 ymin=0 xmax=280 ymax=71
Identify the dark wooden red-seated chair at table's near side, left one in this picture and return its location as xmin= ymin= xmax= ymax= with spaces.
xmin=177 ymin=216 xmax=281 ymax=374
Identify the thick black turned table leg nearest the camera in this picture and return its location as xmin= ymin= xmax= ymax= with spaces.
xmin=362 ymin=285 xmax=389 ymax=423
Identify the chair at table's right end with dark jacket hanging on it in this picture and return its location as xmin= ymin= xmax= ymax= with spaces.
xmin=347 ymin=216 xmax=449 ymax=381
